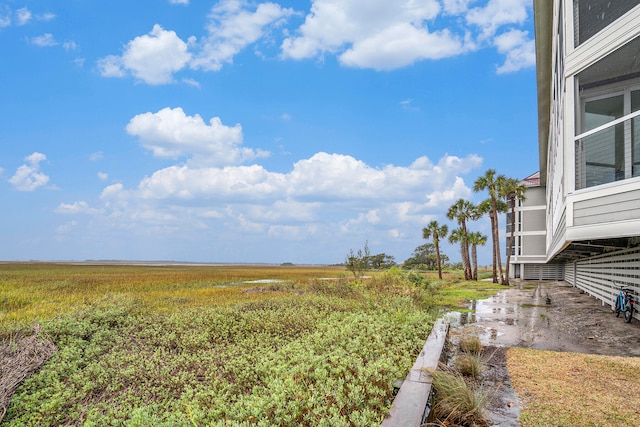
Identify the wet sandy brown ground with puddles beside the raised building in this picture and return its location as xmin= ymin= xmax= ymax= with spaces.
xmin=448 ymin=282 xmax=640 ymax=427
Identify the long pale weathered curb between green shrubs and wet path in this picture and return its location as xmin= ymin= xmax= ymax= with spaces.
xmin=382 ymin=319 xmax=449 ymax=427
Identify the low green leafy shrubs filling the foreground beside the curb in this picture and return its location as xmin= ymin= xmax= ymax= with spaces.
xmin=3 ymin=273 xmax=433 ymax=426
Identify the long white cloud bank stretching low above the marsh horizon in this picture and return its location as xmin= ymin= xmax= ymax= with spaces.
xmin=102 ymin=153 xmax=482 ymax=216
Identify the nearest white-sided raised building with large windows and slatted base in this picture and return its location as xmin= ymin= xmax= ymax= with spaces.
xmin=534 ymin=0 xmax=640 ymax=318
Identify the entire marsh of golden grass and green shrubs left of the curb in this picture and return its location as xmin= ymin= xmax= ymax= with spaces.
xmin=0 ymin=263 xmax=491 ymax=427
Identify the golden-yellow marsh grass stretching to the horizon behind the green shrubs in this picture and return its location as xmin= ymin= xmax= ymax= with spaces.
xmin=0 ymin=263 xmax=345 ymax=336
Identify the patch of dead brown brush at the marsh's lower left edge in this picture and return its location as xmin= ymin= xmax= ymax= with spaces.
xmin=0 ymin=325 xmax=58 ymax=423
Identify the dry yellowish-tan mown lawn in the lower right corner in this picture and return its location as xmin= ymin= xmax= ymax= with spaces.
xmin=507 ymin=348 xmax=640 ymax=427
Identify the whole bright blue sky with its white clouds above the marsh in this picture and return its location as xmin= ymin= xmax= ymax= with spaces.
xmin=0 ymin=0 xmax=538 ymax=264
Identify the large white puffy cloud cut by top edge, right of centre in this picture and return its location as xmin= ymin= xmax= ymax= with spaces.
xmin=282 ymin=0 xmax=464 ymax=70
